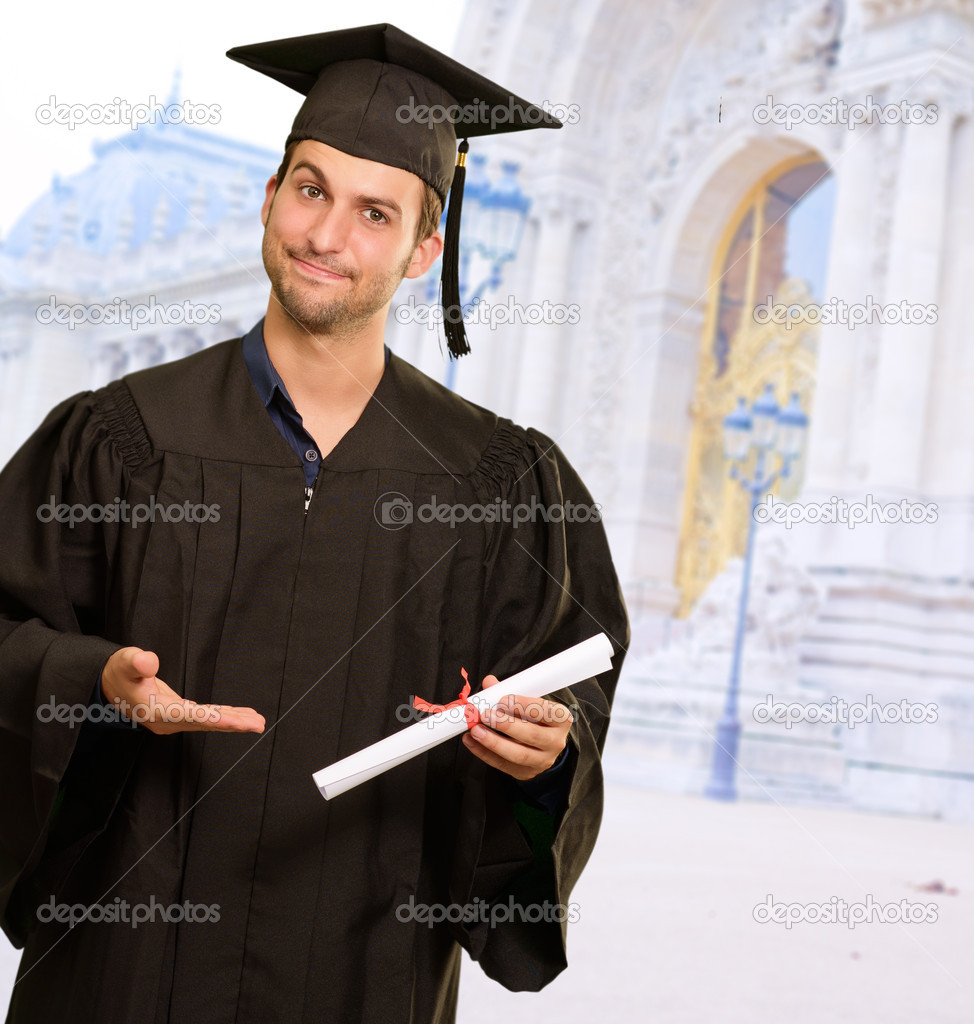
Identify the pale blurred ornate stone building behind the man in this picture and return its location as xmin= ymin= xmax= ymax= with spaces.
xmin=0 ymin=0 xmax=974 ymax=820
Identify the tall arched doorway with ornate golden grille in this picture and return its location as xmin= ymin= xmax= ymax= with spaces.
xmin=676 ymin=153 xmax=835 ymax=615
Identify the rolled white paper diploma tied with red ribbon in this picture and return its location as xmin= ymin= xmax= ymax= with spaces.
xmin=312 ymin=633 xmax=612 ymax=800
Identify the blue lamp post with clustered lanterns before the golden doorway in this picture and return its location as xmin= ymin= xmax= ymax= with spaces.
xmin=704 ymin=384 xmax=808 ymax=800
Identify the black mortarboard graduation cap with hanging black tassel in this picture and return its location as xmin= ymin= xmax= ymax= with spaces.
xmin=226 ymin=25 xmax=561 ymax=357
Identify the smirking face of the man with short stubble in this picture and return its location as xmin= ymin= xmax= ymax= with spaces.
xmin=260 ymin=139 xmax=442 ymax=337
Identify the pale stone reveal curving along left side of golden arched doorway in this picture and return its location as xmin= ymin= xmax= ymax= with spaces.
xmin=610 ymin=132 xmax=821 ymax=614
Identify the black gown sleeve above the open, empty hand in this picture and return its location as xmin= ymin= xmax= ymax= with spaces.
xmin=0 ymin=392 xmax=144 ymax=946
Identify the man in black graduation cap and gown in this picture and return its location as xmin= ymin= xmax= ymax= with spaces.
xmin=0 ymin=26 xmax=628 ymax=1024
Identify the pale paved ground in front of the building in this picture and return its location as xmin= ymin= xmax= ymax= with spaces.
xmin=0 ymin=785 xmax=974 ymax=1024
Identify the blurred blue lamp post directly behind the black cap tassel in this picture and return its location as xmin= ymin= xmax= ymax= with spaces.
xmin=426 ymin=154 xmax=531 ymax=391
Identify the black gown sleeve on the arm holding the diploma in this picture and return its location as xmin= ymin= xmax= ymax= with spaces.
xmin=452 ymin=422 xmax=629 ymax=991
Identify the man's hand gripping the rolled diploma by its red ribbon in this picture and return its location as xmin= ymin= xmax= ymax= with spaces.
xmin=463 ymin=676 xmax=574 ymax=782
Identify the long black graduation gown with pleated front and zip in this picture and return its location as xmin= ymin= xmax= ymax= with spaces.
xmin=0 ymin=340 xmax=629 ymax=1024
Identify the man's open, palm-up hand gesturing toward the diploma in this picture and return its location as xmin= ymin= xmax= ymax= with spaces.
xmin=101 ymin=647 xmax=264 ymax=735
